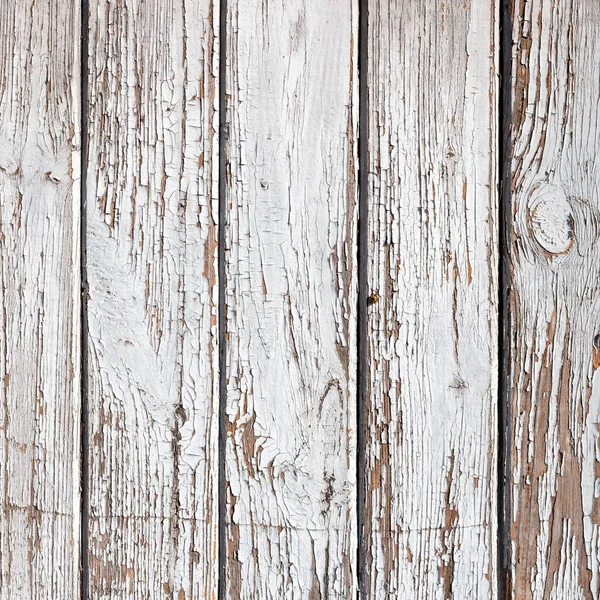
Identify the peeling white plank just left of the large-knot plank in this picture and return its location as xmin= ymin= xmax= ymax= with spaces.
xmin=365 ymin=0 xmax=498 ymax=599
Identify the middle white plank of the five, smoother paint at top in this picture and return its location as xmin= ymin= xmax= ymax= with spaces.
xmin=225 ymin=0 xmax=358 ymax=600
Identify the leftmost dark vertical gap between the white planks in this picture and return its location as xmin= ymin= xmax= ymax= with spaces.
xmin=79 ymin=0 xmax=90 ymax=600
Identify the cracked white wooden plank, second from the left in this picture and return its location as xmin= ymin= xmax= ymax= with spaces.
xmin=86 ymin=0 xmax=219 ymax=600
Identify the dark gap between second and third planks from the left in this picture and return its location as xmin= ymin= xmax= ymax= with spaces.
xmin=217 ymin=0 xmax=227 ymax=600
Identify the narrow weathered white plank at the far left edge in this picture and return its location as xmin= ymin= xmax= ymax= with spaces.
xmin=0 ymin=0 xmax=80 ymax=600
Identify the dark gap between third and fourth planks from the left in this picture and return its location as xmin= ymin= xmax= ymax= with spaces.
xmin=356 ymin=0 xmax=369 ymax=600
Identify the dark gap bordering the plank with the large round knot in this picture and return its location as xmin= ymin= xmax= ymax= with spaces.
xmin=497 ymin=0 xmax=512 ymax=600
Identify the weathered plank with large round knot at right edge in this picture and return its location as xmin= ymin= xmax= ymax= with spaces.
xmin=509 ymin=0 xmax=600 ymax=600
